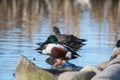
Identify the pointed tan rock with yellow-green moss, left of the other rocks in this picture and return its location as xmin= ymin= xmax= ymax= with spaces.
xmin=15 ymin=56 xmax=55 ymax=80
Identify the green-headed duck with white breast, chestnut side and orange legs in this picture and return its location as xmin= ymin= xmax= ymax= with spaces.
xmin=36 ymin=35 xmax=80 ymax=66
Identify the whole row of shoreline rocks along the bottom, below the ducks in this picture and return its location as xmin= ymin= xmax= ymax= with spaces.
xmin=15 ymin=56 xmax=120 ymax=80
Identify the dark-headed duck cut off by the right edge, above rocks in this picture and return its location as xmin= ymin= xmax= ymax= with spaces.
xmin=110 ymin=40 xmax=120 ymax=61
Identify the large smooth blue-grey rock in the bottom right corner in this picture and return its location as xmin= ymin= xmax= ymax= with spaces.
xmin=92 ymin=55 xmax=120 ymax=80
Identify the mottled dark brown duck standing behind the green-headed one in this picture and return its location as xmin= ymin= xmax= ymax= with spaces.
xmin=53 ymin=26 xmax=87 ymax=50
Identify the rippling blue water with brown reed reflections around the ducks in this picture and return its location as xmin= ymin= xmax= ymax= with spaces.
xmin=0 ymin=0 xmax=120 ymax=80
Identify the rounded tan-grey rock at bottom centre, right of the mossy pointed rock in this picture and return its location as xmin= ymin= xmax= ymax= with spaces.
xmin=58 ymin=67 xmax=96 ymax=80
